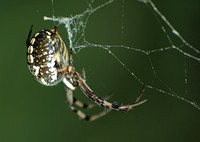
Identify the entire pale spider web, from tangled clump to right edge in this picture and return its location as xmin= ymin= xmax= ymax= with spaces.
xmin=44 ymin=0 xmax=200 ymax=109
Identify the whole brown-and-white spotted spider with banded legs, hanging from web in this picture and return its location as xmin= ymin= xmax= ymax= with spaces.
xmin=26 ymin=25 xmax=146 ymax=121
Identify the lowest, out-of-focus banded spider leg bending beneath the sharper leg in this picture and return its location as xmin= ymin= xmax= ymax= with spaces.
xmin=66 ymin=88 xmax=110 ymax=121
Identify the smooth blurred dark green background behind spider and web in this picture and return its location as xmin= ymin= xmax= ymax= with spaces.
xmin=0 ymin=0 xmax=200 ymax=142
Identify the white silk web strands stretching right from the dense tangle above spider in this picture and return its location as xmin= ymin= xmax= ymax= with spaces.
xmin=44 ymin=0 xmax=200 ymax=109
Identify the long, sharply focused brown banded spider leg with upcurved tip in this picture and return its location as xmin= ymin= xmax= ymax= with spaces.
xmin=76 ymin=77 xmax=146 ymax=111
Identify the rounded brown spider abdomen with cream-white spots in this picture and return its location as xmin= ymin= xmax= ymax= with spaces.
xmin=27 ymin=28 xmax=68 ymax=86
